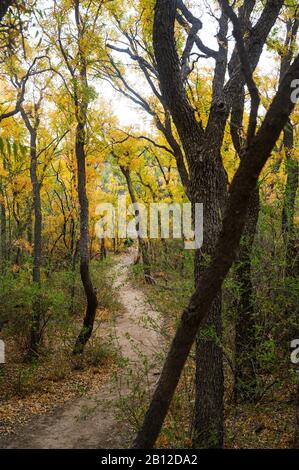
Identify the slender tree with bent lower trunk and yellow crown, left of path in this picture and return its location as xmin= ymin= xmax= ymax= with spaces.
xmin=39 ymin=0 xmax=106 ymax=354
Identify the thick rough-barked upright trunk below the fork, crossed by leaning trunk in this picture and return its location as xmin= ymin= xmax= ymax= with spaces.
xmin=190 ymin=157 xmax=226 ymax=448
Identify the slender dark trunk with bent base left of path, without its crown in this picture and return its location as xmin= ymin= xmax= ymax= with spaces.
xmin=73 ymin=119 xmax=98 ymax=354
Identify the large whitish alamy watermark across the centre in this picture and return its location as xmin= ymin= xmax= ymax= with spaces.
xmin=96 ymin=196 xmax=203 ymax=250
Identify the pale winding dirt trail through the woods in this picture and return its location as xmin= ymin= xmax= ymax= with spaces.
xmin=0 ymin=252 xmax=160 ymax=449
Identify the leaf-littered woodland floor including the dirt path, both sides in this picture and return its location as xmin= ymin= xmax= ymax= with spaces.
xmin=0 ymin=251 xmax=295 ymax=449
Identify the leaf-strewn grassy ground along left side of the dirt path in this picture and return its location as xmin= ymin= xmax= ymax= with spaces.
xmin=0 ymin=257 xmax=122 ymax=434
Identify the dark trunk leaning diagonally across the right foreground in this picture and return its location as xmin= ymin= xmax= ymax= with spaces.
xmin=134 ymin=30 xmax=299 ymax=448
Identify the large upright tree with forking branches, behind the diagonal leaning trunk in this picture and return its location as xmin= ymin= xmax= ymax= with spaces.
xmin=104 ymin=0 xmax=283 ymax=447
